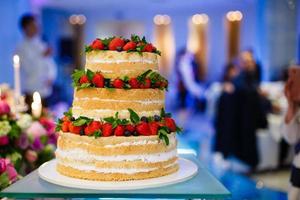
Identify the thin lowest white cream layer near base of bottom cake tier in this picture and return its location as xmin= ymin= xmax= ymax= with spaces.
xmin=62 ymin=162 xmax=177 ymax=174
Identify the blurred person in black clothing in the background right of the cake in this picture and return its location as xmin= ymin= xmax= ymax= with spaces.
xmin=216 ymin=52 xmax=269 ymax=169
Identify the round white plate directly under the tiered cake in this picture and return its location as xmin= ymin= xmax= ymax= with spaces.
xmin=38 ymin=158 xmax=198 ymax=190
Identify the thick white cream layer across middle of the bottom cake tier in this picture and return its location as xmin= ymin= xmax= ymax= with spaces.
xmin=55 ymin=148 xmax=177 ymax=163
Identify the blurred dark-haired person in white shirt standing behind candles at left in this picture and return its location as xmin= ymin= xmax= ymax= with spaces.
xmin=16 ymin=14 xmax=57 ymax=106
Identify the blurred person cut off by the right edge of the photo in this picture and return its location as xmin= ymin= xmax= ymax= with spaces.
xmin=282 ymin=69 xmax=300 ymax=200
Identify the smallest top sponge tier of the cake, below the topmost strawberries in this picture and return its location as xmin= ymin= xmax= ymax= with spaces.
xmin=85 ymin=50 xmax=158 ymax=78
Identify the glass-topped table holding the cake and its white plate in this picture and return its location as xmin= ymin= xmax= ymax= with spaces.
xmin=0 ymin=154 xmax=231 ymax=199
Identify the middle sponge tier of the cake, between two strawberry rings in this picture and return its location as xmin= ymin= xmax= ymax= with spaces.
xmin=72 ymin=88 xmax=165 ymax=119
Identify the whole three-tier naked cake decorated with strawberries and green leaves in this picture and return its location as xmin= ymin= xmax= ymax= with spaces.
xmin=56 ymin=35 xmax=180 ymax=181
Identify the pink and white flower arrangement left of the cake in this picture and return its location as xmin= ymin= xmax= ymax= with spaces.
xmin=0 ymin=100 xmax=58 ymax=190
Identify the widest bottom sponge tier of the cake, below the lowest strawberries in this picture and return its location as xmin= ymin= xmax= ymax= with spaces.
xmin=56 ymin=132 xmax=179 ymax=181
